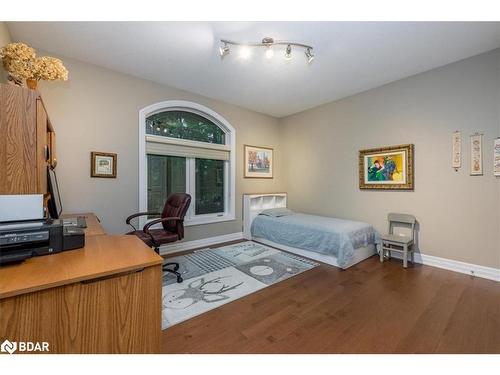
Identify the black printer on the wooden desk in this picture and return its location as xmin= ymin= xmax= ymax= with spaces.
xmin=0 ymin=219 xmax=85 ymax=265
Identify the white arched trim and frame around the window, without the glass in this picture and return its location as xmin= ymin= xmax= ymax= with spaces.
xmin=139 ymin=100 xmax=236 ymax=227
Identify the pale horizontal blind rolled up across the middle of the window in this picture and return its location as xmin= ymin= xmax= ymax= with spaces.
xmin=146 ymin=137 xmax=229 ymax=160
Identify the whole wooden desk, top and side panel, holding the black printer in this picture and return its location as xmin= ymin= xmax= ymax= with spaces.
xmin=0 ymin=214 xmax=163 ymax=353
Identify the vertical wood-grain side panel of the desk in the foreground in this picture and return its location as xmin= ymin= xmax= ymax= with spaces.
xmin=0 ymin=265 xmax=161 ymax=353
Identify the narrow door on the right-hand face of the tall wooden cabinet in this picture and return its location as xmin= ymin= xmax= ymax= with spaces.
xmin=36 ymin=99 xmax=49 ymax=194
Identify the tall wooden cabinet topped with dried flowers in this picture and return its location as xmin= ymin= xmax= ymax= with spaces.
xmin=0 ymin=84 xmax=56 ymax=194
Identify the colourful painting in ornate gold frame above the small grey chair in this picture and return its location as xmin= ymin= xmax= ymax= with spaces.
xmin=359 ymin=144 xmax=414 ymax=190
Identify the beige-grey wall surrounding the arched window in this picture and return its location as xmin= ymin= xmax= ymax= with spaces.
xmin=35 ymin=51 xmax=284 ymax=240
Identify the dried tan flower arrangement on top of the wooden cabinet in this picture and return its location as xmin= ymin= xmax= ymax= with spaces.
xmin=0 ymin=43 xmax=68 ymax=89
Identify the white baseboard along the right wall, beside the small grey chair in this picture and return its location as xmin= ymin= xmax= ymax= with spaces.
xmin=392 ymin=252 xmax=500 ymax=282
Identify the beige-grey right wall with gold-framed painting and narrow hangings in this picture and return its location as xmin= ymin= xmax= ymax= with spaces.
xmin=280 ymin=50 xmax=500 ymax=268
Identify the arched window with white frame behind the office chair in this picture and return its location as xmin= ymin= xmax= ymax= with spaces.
xmin=139 ymin=101 xmax=235 ymax=225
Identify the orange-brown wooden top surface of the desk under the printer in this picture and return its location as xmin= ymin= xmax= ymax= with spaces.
xmin=0 ymin=214 xmax=163 ymax=299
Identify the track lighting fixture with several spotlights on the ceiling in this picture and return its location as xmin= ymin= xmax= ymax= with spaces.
xmin=219 ymin=37 xmax=314 ymax=63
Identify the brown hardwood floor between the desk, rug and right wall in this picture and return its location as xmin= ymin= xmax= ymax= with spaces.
xmin=162 ymin=248 xmax=500 ymax=353
